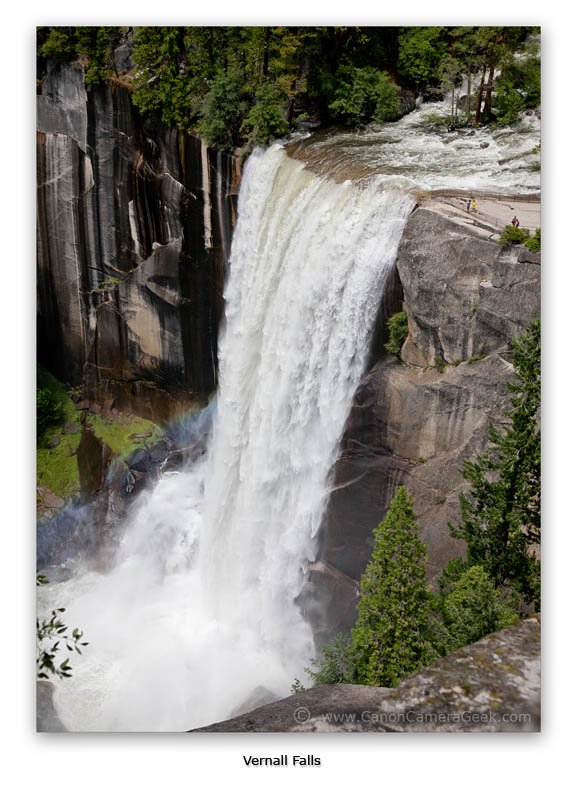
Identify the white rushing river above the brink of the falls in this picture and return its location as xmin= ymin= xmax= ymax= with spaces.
xmin=287 ymin=101 xmax=540 ymax=195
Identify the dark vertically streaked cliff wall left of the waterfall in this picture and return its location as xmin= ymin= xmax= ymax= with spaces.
xmin=37 ymin=65 xmax=240 ymax=419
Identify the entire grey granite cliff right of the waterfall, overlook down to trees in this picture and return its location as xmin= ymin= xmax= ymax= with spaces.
xmin=307 ymin=202 xmax=540 ymax=638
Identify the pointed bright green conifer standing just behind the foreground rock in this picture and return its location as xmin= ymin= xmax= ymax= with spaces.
xmin=351 ymin=487 xmax=433 ymax=686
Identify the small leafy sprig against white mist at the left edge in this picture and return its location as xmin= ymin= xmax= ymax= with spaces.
xmin=36 ymin=574 xmax=88 ymax=680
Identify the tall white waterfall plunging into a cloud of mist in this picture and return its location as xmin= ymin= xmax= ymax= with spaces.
xmin=42 ymin=145 xmax=414 ymax=731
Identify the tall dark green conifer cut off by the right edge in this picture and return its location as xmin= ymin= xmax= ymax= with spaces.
xmin=451 ymin=319 xmax=541 ymax=609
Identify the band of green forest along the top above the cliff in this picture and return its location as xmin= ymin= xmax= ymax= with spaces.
xmin=37 ymin=26 xmax=540 ymax=147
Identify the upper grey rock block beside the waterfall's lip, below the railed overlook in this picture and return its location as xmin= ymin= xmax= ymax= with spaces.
xmin=397 ymin=207 xmax=540 ymax=366
